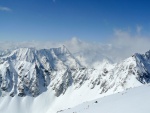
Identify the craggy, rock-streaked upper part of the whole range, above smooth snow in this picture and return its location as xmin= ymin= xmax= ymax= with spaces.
xmin=0 ymin=46 xmax=150 ymax=97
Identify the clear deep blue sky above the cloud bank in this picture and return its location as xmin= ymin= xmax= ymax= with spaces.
xmin=0 ymin=0 xmax=150 ymax=42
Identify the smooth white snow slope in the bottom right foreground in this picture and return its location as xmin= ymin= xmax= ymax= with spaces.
xmin=59 ymin=84 xmax=150 ymax=113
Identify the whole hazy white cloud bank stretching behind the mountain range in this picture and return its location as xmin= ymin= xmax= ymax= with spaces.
xmin=0 ymin=27 xmax=150 ymax=65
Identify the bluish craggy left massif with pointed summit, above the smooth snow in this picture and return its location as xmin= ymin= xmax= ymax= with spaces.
xmin=0 ymin=46 xmax=81 ymax=96
